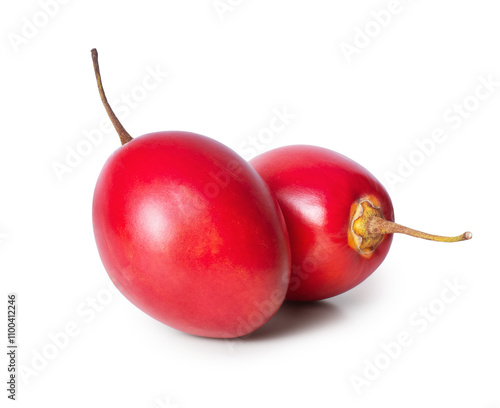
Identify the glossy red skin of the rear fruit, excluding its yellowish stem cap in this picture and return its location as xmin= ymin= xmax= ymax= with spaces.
xmin=250 ymin=145 xmax=394 ymax=301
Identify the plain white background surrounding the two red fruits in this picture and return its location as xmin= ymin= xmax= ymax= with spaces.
xmin=0 ymin=0 xmax=500 ymax=408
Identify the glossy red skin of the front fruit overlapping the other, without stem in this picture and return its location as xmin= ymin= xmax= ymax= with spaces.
xmin=93 ymin=132 xmax=290 ymax=338
